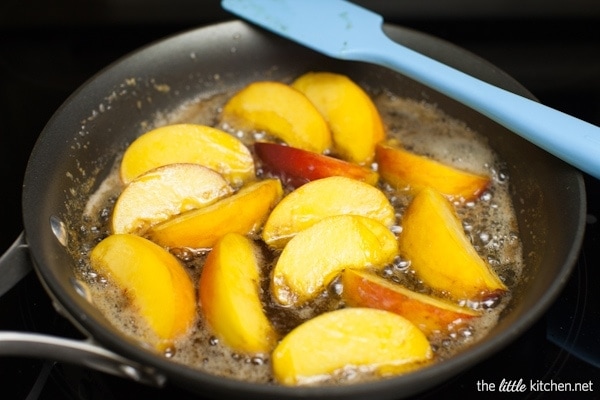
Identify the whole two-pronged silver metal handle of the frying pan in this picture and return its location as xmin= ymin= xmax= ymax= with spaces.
xmin=0 ymin=233 xmax=166 ymax=387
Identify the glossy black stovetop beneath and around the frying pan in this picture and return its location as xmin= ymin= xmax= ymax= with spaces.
xmin=0 ymin=2 xmax=600 ymax=400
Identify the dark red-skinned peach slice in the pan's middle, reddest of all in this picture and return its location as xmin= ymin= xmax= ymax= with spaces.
xmin=254 ymin=142 xmax=379 ymax=188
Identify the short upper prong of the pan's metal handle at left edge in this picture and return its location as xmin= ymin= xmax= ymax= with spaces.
xmin=0 ymin=232 xmax=32 ymax=297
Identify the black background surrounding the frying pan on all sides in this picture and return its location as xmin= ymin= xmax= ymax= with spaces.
xmin=0 ymin=0 xmax=600 ymax=400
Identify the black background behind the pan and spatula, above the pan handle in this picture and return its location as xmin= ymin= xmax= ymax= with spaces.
xmin=0 ymin=0 xmax=600 ymax=248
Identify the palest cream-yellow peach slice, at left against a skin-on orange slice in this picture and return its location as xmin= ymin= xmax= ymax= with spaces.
xmin=111 ymin=164 xmax=233 ymax=234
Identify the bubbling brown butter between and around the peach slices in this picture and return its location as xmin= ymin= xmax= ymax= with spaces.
xmin=79 ymin=86 xmax=523 ymax=384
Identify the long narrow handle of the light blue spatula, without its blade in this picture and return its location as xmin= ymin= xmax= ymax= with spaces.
xmin=360 ymin=31 xmax=600 ymax=179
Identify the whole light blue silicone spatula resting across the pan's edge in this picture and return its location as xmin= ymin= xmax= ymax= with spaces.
xmin=221 ymin=0 xmax=600 ymax=179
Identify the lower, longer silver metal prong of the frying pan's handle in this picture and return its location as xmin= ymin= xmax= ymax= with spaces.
xmin=0 ymin=332 xmax=167 ymax=387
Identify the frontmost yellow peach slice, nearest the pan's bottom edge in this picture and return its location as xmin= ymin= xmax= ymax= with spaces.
xmin=272 ymin=308 xmax=433 ymax=386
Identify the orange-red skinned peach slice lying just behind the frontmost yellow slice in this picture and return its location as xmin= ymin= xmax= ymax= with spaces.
xmin=342 ymin=269 xmax=480 ymax=336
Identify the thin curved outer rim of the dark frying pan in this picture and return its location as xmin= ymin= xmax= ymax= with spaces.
xmin=23 ymin=20 xmax=586 ymax=398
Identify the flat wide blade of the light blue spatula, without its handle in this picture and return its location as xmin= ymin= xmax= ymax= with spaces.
xmin=221 ymin=0 xmax=383 ymax=59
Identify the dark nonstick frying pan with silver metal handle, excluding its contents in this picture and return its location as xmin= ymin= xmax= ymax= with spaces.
xmin=0 ymin=21 xmax=586 ymax=399
